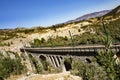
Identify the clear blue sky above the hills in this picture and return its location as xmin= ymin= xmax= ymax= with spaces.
xmin=0 ymin=0 xmax=120 ymax=29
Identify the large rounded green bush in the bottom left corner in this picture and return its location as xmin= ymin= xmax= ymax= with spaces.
xmin=0 ymin=57 xmax=25 ymax=78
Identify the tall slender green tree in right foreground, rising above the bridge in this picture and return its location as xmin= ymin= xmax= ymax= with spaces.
xmin=96 ymin=24 xmax=120 ymax=80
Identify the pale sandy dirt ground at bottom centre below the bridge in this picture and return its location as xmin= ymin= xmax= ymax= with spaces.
xmin=18 ymin=72 xmax=82 ymax=80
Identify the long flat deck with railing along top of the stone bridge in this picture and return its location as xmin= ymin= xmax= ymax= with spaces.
xmin=21 ymin=45 xmax=120 ymax=53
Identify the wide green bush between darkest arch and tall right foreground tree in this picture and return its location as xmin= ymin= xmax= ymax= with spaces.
xmin=71 ymin=59 xmax=108 ymax=80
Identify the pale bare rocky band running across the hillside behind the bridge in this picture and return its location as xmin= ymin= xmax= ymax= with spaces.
xmin=0 ymin=21 xmax=94 ymax=51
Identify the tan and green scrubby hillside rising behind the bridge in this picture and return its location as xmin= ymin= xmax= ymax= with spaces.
xmin=0 ymin=6 xmax=120 ymax=50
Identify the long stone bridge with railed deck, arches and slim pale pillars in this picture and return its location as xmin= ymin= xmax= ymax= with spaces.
xmin=20 ymin=45 xmax=120 ymax=70
